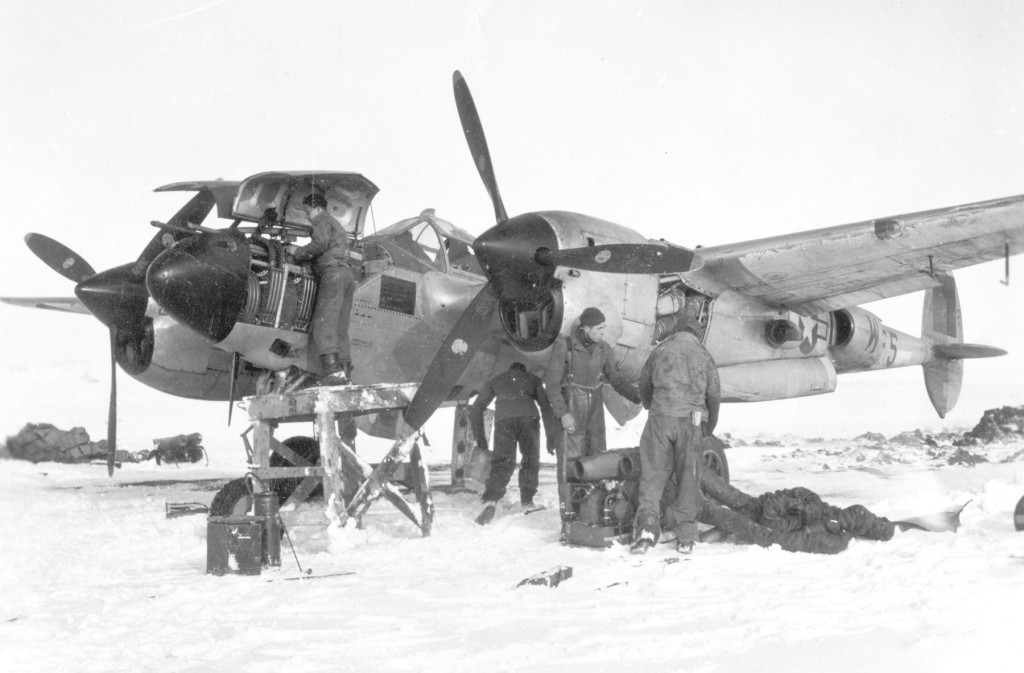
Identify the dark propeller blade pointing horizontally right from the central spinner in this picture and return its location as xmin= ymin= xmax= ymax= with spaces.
xmin=536 ymin=243 xmax=703 ymax=274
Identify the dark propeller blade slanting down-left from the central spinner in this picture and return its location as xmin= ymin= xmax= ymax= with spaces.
xmin=406 ymin=283 xmax=498 ymax=430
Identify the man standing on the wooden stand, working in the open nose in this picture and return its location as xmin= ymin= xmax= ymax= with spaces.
xmin=294 ymin=193 xmax=355 ymax=385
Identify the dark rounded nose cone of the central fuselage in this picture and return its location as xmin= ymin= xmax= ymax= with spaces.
xmin=145 ymin=230 xmax=251 ymax=342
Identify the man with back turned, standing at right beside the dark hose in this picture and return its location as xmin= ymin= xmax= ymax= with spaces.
xmin=631 ymin=299 xmax=721 ymax=554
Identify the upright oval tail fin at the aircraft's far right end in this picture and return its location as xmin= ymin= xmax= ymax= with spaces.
xmin=921 ymin=274 xmax=964 ymax=418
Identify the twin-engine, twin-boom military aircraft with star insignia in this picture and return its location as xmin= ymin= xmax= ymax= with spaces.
xmin=4 ymin=72 xmax=1024 ymax=477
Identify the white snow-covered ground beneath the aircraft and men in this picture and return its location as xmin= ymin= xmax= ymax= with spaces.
xmin=0 ymin=430 xmax=1024 ymax=673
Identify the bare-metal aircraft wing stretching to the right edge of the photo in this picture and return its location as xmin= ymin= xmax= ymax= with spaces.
xmin=687 ymin=195 xmax=1024 ymax=316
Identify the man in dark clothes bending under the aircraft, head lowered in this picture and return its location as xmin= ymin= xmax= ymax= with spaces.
xmin=469 ymin=363 xmax=557 ymax=525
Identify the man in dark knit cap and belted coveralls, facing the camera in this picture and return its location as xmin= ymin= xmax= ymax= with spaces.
xmin=545 ymin=306 xmax=640 ymax=522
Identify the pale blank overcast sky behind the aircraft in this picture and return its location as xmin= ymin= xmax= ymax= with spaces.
xmin=0 ymin=0 xmax=1024 ymax=444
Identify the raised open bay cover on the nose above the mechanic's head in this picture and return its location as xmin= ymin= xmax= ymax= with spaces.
xmin=232 ymin=171 xmax=379 ymax=238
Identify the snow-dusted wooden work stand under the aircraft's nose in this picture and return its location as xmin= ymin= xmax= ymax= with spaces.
xmin=244 ymin=383 xmax=434 ymax=536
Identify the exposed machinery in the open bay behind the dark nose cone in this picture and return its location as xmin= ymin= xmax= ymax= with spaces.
xmin=239 ymin=240 xmax=316 ymax=332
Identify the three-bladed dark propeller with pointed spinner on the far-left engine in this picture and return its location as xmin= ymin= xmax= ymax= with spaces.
xmin=25 ymin=191 xmax=216 ymax=476
